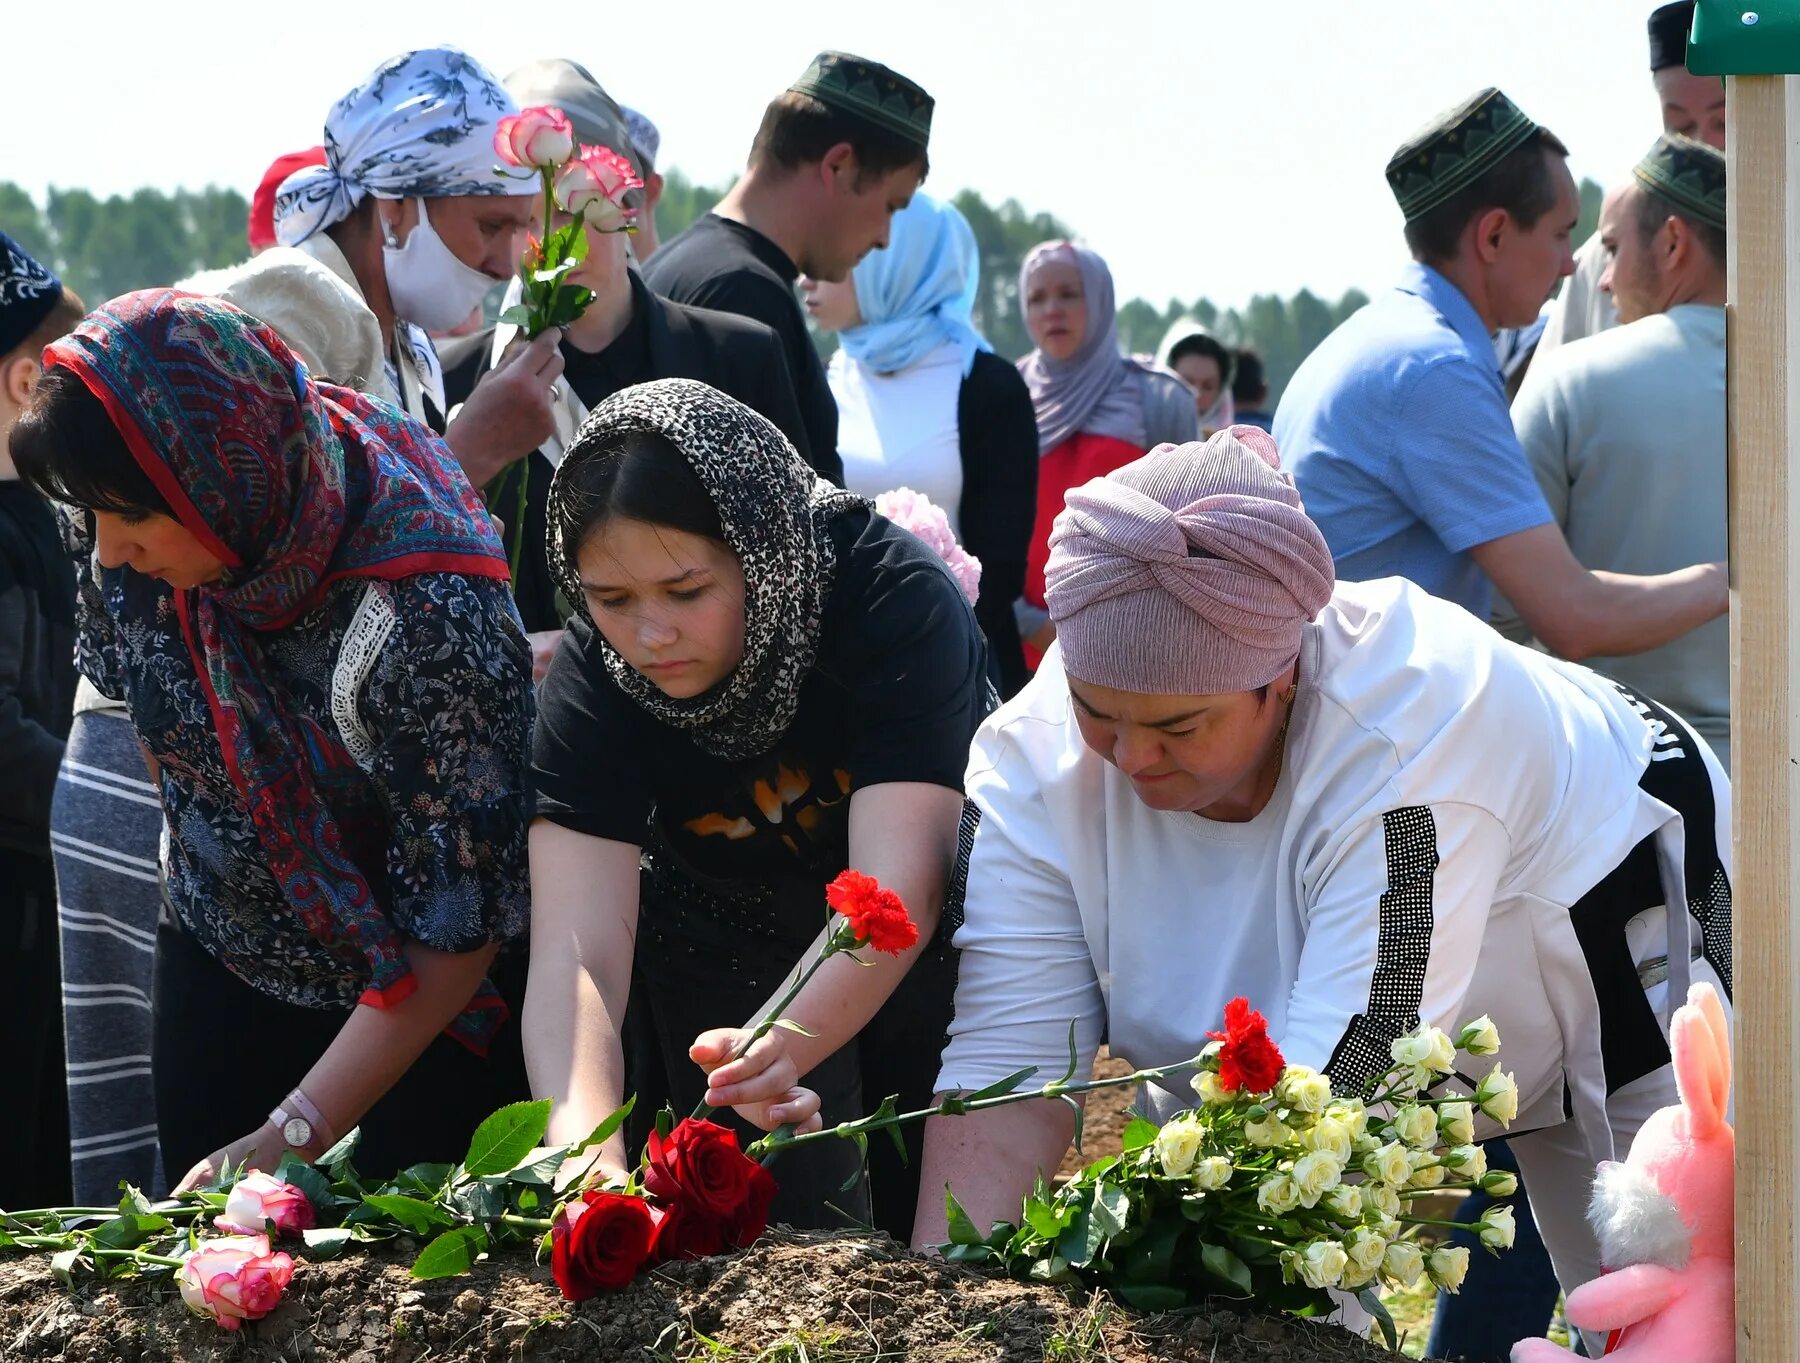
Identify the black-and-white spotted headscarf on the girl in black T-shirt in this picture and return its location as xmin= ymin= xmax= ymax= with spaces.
xmin=549 ymin=378 xmax=868 ymax=762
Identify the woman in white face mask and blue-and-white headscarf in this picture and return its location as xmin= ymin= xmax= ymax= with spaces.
xmin=266 ymin=47 xmax=562 ymax=488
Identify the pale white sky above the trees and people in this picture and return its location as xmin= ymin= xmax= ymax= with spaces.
xmin=0 ymin=0 xmax=1661 ymax=306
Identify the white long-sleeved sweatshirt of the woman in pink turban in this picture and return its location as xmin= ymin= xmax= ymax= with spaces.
xmin=938 ymin=578 xmax=1706 ymax=1151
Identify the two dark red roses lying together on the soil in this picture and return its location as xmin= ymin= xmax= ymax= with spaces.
xmin=551 ymin=1118 xmax=776 ymax=1302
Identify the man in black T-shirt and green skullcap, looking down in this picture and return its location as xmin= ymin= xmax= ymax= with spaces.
xmin=644 ymin=52 xmax=932 ymax=483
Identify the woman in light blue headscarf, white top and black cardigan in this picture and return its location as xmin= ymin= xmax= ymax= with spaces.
xmin=801 ymin=194 xmax=1037 ymax=695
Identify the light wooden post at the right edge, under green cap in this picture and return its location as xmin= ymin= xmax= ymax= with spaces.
xmin=1726 ymin=76 xmax=1800 ymax=1363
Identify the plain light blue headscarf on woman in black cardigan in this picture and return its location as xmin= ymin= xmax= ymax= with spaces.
xmin=839 ymin=194 xmax=994 ymax=375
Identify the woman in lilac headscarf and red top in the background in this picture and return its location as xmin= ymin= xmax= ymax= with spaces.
xmin=1019 ymin=241 xmax=1199 ymax=666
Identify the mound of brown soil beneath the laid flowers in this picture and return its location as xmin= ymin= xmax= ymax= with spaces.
xmin=0 ymin=1232 xmax=1432 ymax=1363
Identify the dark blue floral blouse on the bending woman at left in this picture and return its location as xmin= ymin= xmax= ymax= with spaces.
xmin=76 ymin=543 xmax=533 ymax=1008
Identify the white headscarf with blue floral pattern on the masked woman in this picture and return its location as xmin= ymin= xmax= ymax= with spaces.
xmin=275 ymin=47 xmax=538 ymax=247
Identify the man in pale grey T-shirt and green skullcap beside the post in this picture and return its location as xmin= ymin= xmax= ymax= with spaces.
xmin=1501 ymin=133 xmax=1732 ymax=767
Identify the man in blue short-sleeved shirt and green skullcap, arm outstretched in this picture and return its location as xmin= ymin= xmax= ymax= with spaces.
xmin=1274 ymin=88 xmax=1726 ymax=659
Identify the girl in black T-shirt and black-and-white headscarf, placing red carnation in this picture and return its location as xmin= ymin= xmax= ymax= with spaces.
xmin=526 ymin=380 xmax=988 ymax=1233
